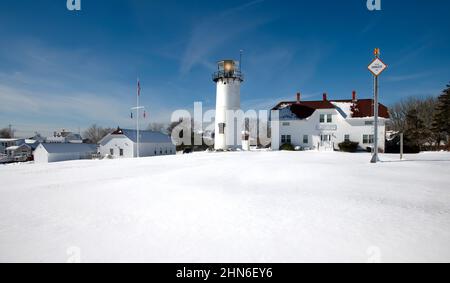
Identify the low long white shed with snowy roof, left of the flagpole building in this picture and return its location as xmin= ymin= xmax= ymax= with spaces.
xmin=33 ymin=143 xmax=97 ymax=163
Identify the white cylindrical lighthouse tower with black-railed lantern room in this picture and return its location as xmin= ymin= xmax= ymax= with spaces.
xmin=213 ymin=60 xmax=244 ymax=150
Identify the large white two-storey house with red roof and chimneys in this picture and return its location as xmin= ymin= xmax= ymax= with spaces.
xmin=272 ymin=92 xmax=389 ymax=151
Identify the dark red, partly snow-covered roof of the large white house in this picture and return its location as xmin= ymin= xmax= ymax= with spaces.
xmin=272 ymin=99 xmax=390 ymax=119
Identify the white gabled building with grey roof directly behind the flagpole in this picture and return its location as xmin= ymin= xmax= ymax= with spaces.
xmin=99 ymin=129 xmax=176 ymax=158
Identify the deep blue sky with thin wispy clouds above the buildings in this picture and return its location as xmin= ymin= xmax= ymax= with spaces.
xmin=0 ymin=0 xmax=450 ymax=138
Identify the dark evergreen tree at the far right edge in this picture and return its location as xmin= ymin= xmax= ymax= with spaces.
xmin=433 ymin=85 xmax=450 ymax=148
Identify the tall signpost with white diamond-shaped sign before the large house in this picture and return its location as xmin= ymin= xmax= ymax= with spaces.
xmin=369 ymin=48 xmax=387 ymax=163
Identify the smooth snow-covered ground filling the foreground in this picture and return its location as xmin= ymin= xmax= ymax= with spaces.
xmin=0 ymin=152 xmax=450 ymax=262
